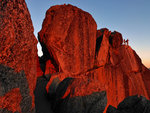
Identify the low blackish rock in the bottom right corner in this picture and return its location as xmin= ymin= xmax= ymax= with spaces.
xmin=107 ymin=95 xmax=150 ymax=113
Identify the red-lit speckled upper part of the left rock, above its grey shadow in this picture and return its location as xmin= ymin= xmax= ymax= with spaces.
xmin=0 ymin=0 xmax=37 ymax=107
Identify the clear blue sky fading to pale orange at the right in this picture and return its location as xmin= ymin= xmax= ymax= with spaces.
xmin=26 ymin=0 xmax=150 ymax=67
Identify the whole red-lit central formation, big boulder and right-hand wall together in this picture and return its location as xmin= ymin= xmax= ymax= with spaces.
xmin=39 ymin=5 xmax=150 ymax=113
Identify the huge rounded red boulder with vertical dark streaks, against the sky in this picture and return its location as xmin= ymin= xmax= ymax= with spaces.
xmin=39 ymin=5 xmax=97 ymax=74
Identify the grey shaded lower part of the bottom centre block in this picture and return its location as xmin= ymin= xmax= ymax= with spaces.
xmin=60 ymin=91 xmax=107 ymax=113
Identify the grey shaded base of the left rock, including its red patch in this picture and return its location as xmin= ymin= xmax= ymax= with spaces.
xmin=0 ymin=64 xmax=35 ymax=113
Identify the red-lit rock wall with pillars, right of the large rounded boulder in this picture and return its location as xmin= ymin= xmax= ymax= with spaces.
xmin=97 ymin=29 xmax=150 ymax=112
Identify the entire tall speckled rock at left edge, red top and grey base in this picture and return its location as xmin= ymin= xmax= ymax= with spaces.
xmin=0 ymin=0 xmax=37 ymax=113
